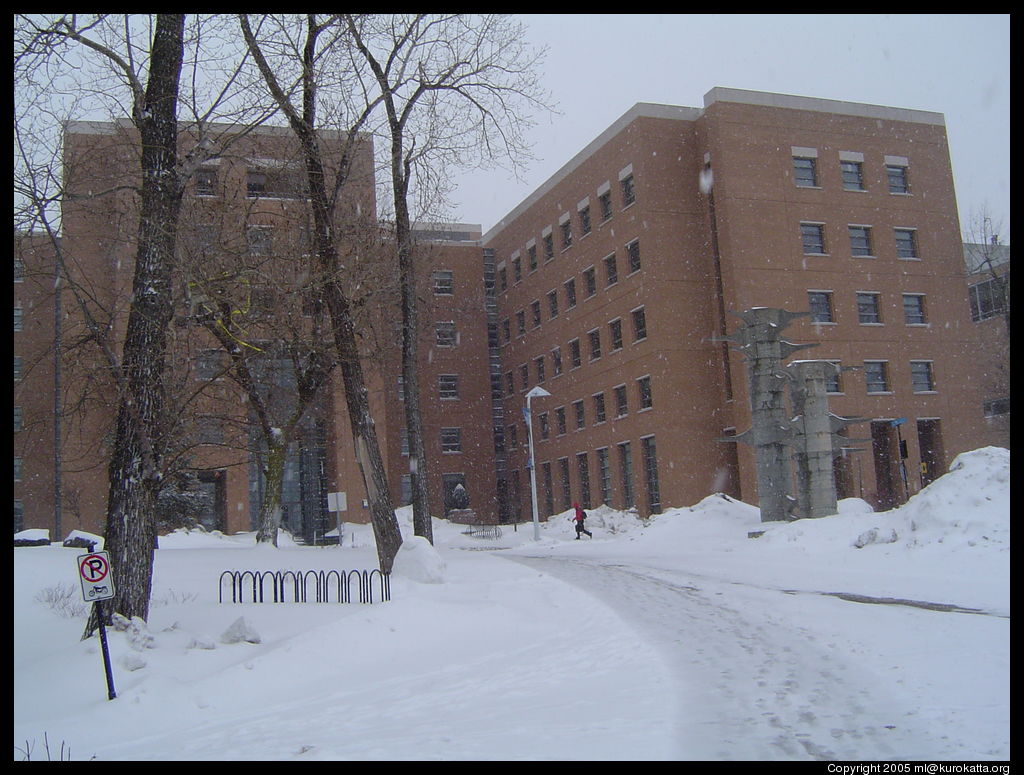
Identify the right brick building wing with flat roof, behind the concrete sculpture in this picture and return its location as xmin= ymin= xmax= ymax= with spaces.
xmin=483 ymin=88 xmax=981 ymax=515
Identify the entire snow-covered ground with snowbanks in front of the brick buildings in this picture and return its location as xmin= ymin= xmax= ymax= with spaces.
xmin=14 ymin=447 xmax=1010 ymax=761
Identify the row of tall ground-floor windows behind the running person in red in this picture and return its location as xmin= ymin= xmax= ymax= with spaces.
xmin=512 ymin=436 xmax=662 ymax=516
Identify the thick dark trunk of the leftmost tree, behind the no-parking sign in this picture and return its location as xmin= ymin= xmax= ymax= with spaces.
xmin=86 ymin=13 xmax=184 ymax=636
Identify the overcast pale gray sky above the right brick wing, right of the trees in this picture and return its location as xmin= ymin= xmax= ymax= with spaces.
xmin=455 ymin=13 xmax=1010 ymax=243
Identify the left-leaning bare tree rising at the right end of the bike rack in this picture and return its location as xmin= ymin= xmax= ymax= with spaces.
xmin=239 ymin=14 xmax=401 ymax=571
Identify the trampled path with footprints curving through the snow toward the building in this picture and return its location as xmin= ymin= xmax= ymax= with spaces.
xmin=510 ymin=557 xmax=982 ymax=761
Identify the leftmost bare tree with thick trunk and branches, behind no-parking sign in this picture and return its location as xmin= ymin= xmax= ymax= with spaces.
xmin=15 ymin=14 xmax=260 ymax=636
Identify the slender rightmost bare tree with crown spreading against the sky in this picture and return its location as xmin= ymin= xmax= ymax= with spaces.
xmin=344 ymin=14 xmax=546 ymax=542
